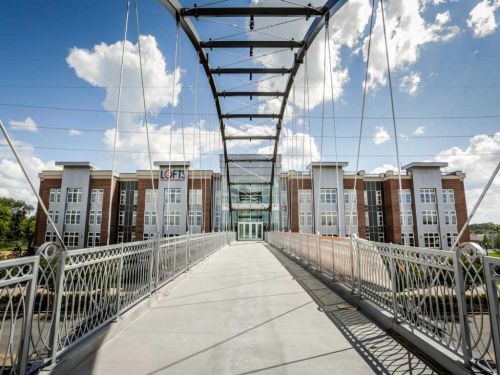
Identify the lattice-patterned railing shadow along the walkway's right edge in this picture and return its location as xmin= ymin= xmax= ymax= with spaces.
xmin=266 ymin=245 xmax=442 ymax=374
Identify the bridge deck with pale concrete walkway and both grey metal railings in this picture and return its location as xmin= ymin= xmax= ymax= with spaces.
xmin=0 ymin=232 xmax=500 ymax=374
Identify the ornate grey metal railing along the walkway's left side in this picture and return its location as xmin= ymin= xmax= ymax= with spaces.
xmin=0 ymin=232 xmax=230 ymax=374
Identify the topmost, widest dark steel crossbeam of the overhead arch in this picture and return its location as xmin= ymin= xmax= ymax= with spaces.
xmin=179 ymin=6 xmax=326 ymax=17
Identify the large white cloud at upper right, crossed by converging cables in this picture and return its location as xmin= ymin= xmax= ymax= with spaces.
xmin=363 ymin=0 xmax=460 ymax=89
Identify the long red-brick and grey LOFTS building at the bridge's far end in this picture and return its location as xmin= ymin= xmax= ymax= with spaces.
xmin=35 ymin=155 xmax=469 ymax=249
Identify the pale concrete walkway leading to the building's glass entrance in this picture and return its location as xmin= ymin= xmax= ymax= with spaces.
xmin=67 ymin=242 xmax=434 ymax=375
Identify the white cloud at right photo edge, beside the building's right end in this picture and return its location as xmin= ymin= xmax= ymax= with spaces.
xmin=436 ymin=132 xmax=500 ymax=223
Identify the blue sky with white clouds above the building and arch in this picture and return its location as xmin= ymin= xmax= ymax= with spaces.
xmin=0 ymin=0 xmax=500 ymax=222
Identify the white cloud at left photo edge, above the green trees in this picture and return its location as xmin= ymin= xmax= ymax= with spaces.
xmin=0 ymin=140 xmax=56 ymax=207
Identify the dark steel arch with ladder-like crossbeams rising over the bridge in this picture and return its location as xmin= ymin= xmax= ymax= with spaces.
xmin=160 ymin=0 xmax=348 ymax=228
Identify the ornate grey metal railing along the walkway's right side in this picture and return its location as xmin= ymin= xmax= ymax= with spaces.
xmin=267 ymin=232 xmax=500 ymax=374
